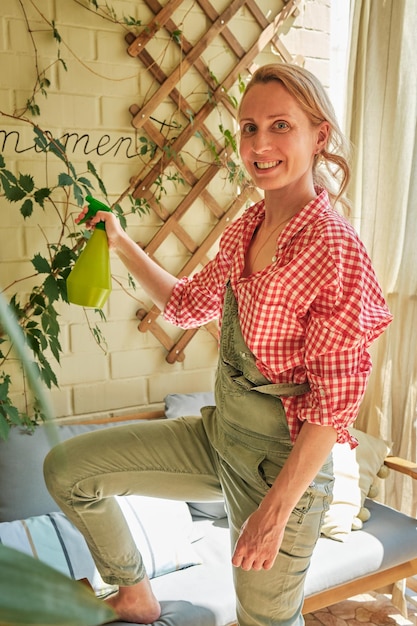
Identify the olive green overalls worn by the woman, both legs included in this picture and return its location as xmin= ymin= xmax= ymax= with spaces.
xmin=45 ymin=286 xmax=332 ymax=626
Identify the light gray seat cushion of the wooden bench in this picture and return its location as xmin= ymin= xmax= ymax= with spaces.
xmin=105 ymin=500 xmax=417 ymax=626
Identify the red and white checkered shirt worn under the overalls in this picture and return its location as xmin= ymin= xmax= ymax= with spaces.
xmin=164 ymin=190 xmax=392 ymax=446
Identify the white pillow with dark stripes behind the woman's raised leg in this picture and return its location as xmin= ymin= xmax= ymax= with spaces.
xmin=0 ymin=496 xmax=200 ymax=596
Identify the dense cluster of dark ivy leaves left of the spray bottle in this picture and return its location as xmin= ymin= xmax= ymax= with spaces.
xmin=0 ymin=126 xmax=106 ymax=439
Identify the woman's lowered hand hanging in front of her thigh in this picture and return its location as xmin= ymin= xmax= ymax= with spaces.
xmin=232 ymin=506 xmax=285 ymax=571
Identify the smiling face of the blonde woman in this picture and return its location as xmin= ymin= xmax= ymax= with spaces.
xmin=239 ymin=80 xmax=329 ymax=201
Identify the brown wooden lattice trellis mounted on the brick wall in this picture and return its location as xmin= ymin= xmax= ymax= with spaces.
xmin=126 ymin=0 xmax=301 ymax=363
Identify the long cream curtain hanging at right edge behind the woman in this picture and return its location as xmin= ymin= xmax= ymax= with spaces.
xmin=346 ymin=0 xmax=417 ymax=515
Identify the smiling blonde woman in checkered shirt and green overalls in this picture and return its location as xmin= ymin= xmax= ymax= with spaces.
xmin=45 ymin=64 xmax=391 ymax=626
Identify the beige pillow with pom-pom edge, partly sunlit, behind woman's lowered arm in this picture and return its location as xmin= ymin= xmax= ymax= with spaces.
xmin=321 ymin=428 xmax=390 ymax=541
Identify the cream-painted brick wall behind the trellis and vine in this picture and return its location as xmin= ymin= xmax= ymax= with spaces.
xmin=0 ymin=0 xmax=330 ymax=417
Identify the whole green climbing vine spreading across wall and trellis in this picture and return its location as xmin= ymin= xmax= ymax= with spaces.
xmin=0 ymin=0 xmax=245 ymax=439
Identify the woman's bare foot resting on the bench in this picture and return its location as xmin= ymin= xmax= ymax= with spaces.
xmin=105 ymin=578 xmax=161 ymax=624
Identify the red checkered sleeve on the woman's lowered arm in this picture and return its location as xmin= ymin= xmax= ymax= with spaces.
xmin=284 ymin=241 xmax=392 ymax=447
